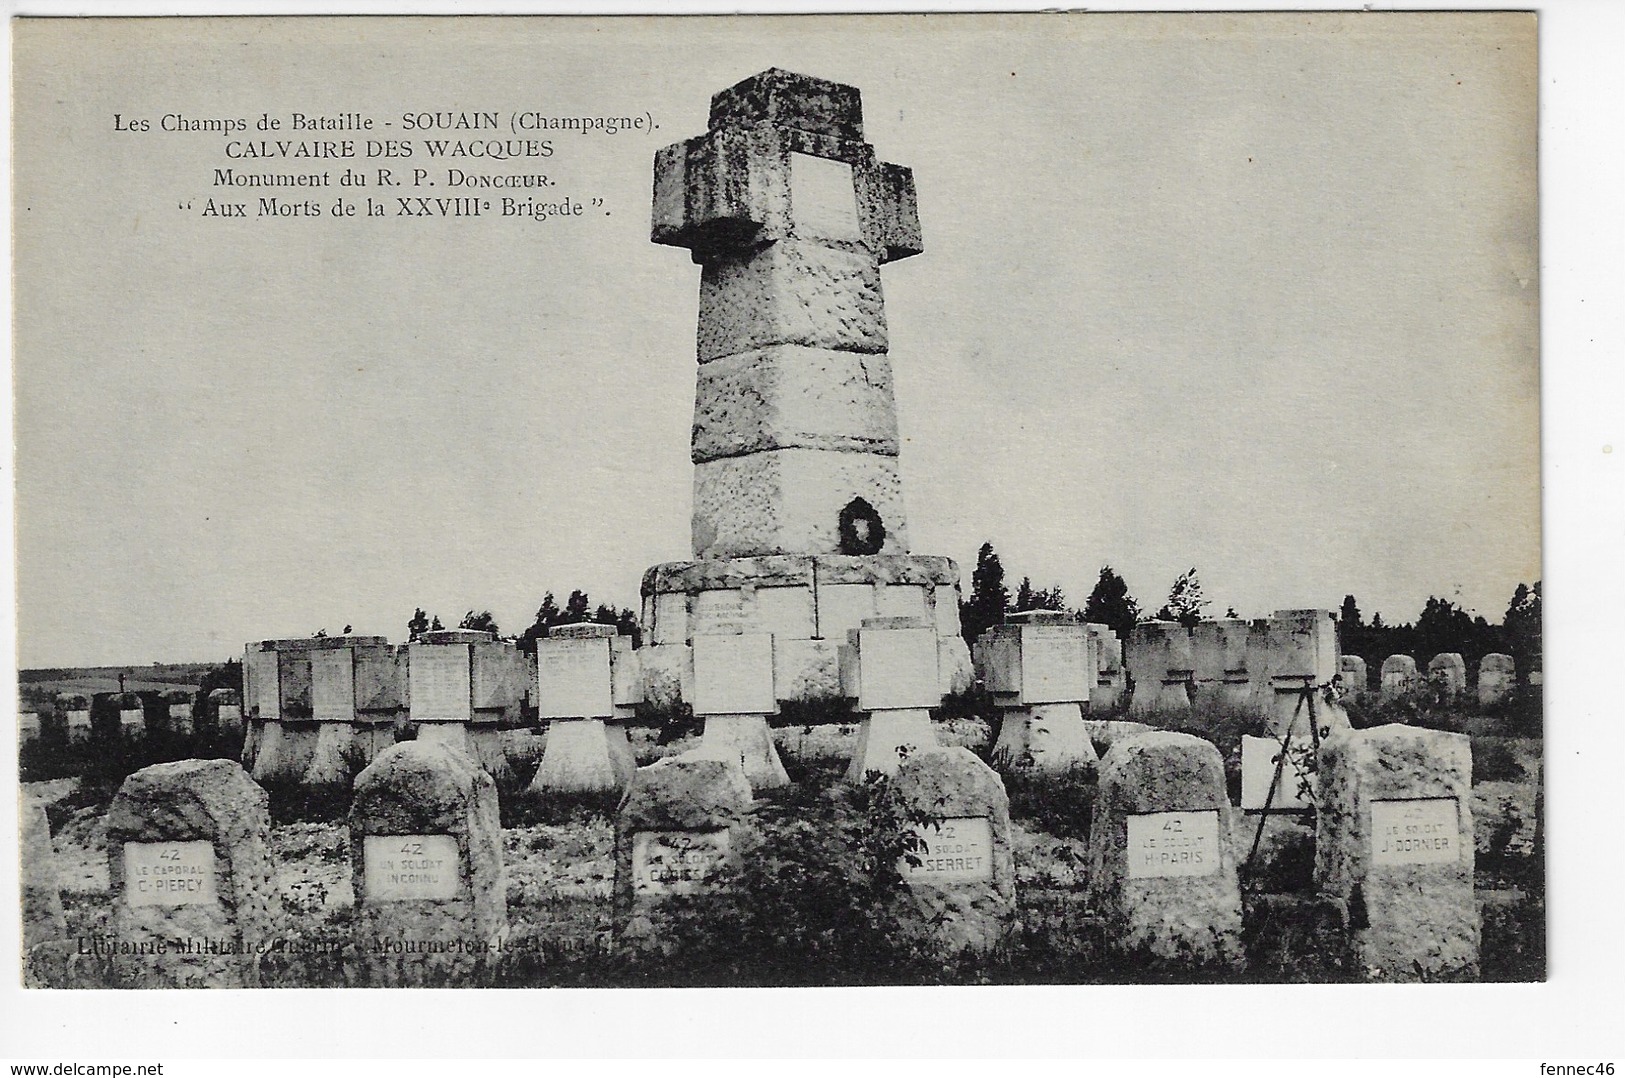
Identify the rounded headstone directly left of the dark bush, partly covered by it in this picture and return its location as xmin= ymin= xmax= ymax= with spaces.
xmin=614 ymin=754 xmax=751 ymax=950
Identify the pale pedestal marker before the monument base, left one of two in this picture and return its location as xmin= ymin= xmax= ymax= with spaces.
xmin=694 ymin=632 xmax=790 ymax=790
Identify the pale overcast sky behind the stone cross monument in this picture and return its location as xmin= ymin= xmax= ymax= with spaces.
xmin=15 ymin=15 xmax=1541 ymax=667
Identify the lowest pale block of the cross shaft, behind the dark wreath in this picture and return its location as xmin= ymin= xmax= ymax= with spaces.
xmin=692 ymin=449 xmax=908 ymax=558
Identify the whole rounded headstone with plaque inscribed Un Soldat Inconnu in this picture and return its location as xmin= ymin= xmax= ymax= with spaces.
xmin=349 ymin=741 xmax=507 ymax=987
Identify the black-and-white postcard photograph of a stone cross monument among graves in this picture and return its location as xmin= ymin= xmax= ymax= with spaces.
xmin=0 ymin=10 xmax=1617 ymax=1058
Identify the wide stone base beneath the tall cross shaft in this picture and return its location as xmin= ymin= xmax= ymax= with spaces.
xmin=639 ymin=554 xmax=972 ymax=706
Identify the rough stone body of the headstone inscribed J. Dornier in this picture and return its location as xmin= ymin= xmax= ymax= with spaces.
xmin=1315 ymin=724 xmax=1479 ymax=980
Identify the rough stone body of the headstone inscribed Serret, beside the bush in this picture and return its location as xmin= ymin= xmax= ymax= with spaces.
xmin=886 ymin=748 xmax=1016 ymax=954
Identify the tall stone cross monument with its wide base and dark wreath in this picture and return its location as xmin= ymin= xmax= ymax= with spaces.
xmin=642 ymin=68 xmax=970 ymax=701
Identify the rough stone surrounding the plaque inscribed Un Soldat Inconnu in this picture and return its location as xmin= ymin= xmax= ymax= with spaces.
xmin=349 ymin=741 xmax=507 ymax=985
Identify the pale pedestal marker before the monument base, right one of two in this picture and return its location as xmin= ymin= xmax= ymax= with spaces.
xmin=842 ymin=618 xmax=943 ymax=782
